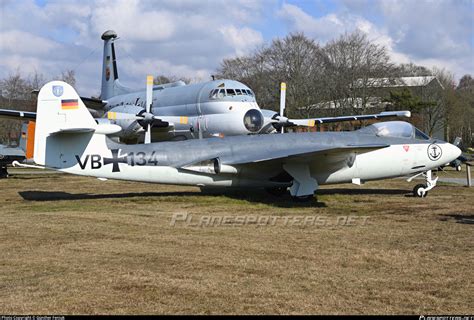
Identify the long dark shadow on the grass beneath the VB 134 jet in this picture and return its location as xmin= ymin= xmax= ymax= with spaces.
xmin=18 ymin=190 xmax=326 ymax=208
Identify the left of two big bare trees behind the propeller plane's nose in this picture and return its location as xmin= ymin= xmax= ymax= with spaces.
xmin=218 ymin=33 xmax=324 ymax=115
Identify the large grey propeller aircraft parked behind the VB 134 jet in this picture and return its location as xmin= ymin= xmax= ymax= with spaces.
xmin=0 ymin=30 xmax=410 ymax=143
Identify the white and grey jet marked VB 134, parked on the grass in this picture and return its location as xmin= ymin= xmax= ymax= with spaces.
xmin=12 ymin=81 xmax=461 ymax=199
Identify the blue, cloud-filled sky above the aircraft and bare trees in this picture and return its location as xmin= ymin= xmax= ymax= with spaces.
xmin=0 ymin=0 xmax=474 ymax=96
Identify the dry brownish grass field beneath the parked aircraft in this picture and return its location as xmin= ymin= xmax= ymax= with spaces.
xmin=0 ymin=172 xmax=474 ymax=314
